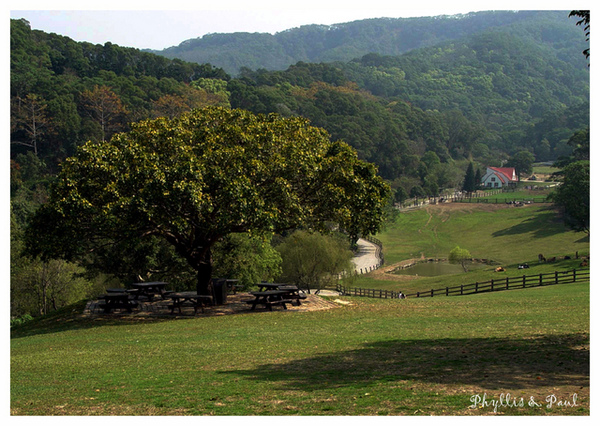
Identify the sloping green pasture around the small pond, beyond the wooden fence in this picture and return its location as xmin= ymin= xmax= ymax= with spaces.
xmin=358 ymin=203 xmax=590 ymax=293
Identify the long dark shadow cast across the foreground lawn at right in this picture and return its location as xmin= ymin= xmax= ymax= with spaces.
xmin=221 ymin=334 xmax=590 ymax=391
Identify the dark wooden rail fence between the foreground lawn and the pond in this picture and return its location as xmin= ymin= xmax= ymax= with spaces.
xmin=336 ymin=269 xmax=590 ymax=299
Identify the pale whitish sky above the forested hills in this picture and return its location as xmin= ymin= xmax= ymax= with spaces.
xmin=9 ymin=0 xmax=589 ymax=50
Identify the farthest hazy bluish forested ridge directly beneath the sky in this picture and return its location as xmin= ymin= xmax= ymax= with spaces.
xmin=153 ymin=11 xmax=585 ymax=75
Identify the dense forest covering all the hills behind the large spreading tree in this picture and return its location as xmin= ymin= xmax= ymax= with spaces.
xmin=10 ymin=12 xmax=589 ymax=315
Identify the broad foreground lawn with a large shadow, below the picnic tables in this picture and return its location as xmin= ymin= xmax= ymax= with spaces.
xmin=11 ymin=283 xmax=589 ymax=415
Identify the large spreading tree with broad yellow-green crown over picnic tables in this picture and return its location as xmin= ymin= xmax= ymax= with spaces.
xmin=27 ymin=107 xmax=390 ymax=294
